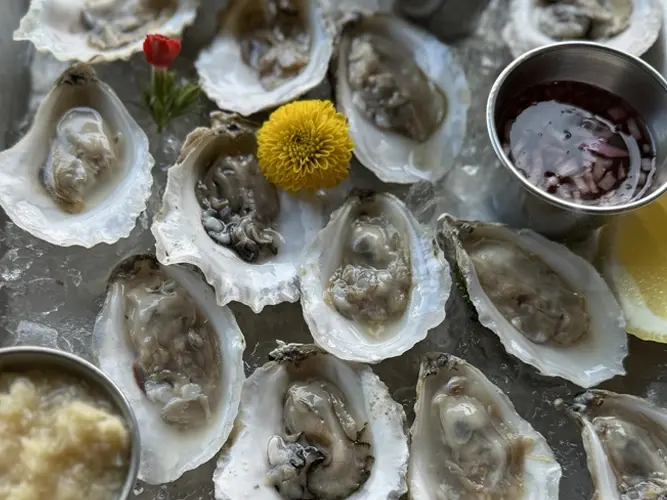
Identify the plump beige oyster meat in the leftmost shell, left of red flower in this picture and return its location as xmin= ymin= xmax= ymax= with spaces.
xmin=42 ymin=107 xmax=120 ymax=213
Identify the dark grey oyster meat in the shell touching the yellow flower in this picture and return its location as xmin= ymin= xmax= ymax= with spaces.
xmin=195 ymin=154 xmax=280 ymax=262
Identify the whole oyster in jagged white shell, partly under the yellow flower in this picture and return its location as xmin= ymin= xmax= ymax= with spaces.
xmin=151 ymin=112 xmax=324 ymax=312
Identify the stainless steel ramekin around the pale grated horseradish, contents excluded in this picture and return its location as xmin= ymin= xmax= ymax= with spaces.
xmin=0 ymin=346 xmax=141 ymax=500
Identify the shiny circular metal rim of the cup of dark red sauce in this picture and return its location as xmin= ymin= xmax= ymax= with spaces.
xmin=486 ymin=41 xmax=667 ymax=216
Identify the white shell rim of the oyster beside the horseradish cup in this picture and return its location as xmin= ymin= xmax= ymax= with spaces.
xmin=92 ymin=254 xmax=246 ymax=485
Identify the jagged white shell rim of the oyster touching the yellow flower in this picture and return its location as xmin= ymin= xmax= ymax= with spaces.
xmin=151 ymin=111 xmax=324 ymax=314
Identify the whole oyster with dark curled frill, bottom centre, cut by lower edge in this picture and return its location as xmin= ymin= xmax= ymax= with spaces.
xmin=213 ymin=343 xmax=408 ymax=500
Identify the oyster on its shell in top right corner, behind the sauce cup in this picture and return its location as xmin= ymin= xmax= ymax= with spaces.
xmin=503 ymin=0 xmax=663 ymax=57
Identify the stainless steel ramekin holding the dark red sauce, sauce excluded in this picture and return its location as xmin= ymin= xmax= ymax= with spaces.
xmin=486 ymin=42 xmax=667 ymax=239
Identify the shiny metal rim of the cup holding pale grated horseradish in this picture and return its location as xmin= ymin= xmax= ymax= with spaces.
xmin=0 ymin=346 xmax=141 ymax=500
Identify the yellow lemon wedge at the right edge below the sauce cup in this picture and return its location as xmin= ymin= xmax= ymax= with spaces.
xmin=599 ymin=196 xmax=667 ymax=343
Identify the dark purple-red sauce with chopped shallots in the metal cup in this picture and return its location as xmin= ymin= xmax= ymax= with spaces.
xmin=499 ymin=82 xmax=655 ymax=205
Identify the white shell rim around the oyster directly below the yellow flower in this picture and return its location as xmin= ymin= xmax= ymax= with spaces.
xmin=299 ymin=192 xmax=453 ymax=364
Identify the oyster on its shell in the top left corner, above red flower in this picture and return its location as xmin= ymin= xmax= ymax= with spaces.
xmin=14 ymin=0 xmax=199 ymax=63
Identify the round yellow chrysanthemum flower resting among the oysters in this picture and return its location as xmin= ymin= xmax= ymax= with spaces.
xmin=257 ymin=101 xmax=354 ymax=192
